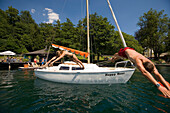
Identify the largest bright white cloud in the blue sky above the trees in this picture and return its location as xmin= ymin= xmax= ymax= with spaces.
xmin=43 ymin=8 xmax=60 ymax=23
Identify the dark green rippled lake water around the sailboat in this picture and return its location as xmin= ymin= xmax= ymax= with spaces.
xmin=0 ymin=67 xmax=170 ymax=113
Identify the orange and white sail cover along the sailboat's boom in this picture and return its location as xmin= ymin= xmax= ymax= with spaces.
xmin=52 ymin=44 xmax=88 ymax=57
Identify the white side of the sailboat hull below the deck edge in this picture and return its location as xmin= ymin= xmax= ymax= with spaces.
xmin=35 ymin=70 xmax=134 ymax=84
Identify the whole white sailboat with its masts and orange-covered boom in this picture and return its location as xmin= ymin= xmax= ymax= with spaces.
xmin=34 ymin=0 xmax=135 ymax=84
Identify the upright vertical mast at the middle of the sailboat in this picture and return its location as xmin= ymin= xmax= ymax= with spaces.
xmin=86 ymin=0 xmax=90 ymax=64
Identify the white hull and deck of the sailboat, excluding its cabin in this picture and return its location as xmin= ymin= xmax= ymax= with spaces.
xmin=34 ymin=62 xmax=135 ymax=84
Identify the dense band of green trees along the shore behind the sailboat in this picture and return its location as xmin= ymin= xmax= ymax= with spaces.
xmin=0 ymin=6 xmax=170 ymax=58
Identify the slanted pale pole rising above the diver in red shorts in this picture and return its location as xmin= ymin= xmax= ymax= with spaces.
xmin=107 ymin=0 xmax=127 ymax=47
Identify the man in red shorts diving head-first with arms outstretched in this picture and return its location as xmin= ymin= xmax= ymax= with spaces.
xmin=110 ymin=47 xmax=170 ymax=98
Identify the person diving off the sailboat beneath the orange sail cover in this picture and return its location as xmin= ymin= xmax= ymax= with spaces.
xmin=44 ymin=50 xmax=84 ymax=69
